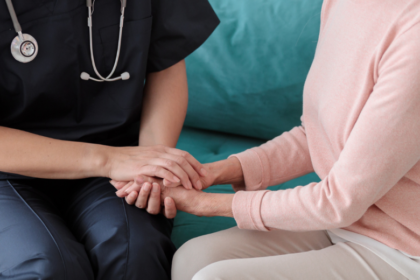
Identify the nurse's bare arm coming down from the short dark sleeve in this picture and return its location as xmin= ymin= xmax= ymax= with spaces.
xmin=139 ymin=61 xmax=188 ymax=147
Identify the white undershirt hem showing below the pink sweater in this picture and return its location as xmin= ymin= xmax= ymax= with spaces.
xmin=327 ymin=229 xmax=420 ymax=280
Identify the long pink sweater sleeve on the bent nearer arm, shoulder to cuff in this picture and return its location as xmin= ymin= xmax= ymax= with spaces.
xmin=232 ymin=24 xmax=420 ymax=231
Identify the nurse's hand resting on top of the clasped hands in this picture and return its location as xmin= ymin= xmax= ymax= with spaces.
xmin=106 ymin=146 xmax=207 ymax=190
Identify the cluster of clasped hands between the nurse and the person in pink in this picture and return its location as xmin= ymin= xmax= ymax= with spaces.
xmin=106 ymin=146 xmax=215 ymax=218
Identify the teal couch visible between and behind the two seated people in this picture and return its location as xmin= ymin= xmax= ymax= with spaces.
xmin=172 ymin=0 xmax=322 ymax=247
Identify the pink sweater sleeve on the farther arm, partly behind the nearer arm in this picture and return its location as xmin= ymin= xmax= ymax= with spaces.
xmin=233 ymin=123 xmax=313 ymax=191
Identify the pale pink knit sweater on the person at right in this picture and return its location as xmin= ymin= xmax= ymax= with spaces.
xmin=233 ymin=0 xmax=420 ymax=256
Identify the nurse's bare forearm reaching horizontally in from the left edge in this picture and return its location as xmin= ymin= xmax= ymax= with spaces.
xmin=0 ymin=127 xmax=106 ymax=179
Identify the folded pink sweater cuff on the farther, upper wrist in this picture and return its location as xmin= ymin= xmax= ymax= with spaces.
xmin=229 ymin=149 xmax=263 ymax=192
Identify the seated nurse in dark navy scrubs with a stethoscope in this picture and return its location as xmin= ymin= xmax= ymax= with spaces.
xmin=0 ymin=0 xmax=219 ymax=280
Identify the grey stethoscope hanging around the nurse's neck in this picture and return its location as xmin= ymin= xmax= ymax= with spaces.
xmin=6 ymin=0 xmax=130 ymax=82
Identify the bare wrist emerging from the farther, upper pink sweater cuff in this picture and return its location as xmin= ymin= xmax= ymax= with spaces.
xmin=208 ymin=157 xmax=244 ymax=185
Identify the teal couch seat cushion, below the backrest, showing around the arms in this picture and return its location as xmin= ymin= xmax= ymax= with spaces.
xmin=172 ymin=128 xmax=319 ymax=247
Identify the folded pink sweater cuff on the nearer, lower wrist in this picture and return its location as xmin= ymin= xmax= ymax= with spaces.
xmin=232 ymin=191 xmax=269 ymax=231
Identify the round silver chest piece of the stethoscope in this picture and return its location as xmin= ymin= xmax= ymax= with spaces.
xmin=10 ymin=34 xmax=38 ymax=63
